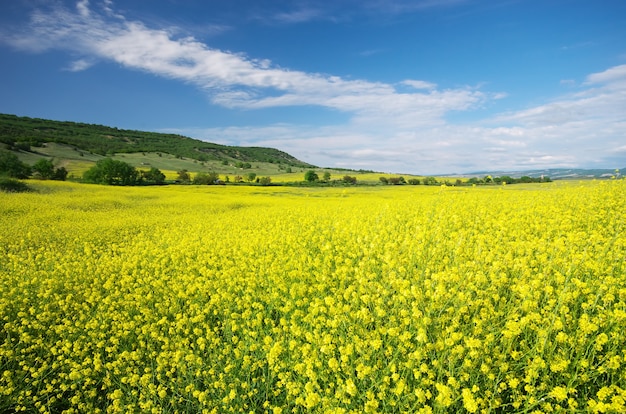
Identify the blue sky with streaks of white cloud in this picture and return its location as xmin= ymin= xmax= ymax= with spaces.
xmin=0 ymin=0 xmax=626 ymax=174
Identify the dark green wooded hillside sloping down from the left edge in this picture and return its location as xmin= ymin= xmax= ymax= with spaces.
xmin=0 ymin=114 xmax=314 ymax=168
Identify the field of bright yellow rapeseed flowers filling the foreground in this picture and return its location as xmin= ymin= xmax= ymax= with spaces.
xmin=0 ymin=180 xmax=626 ymax=413
